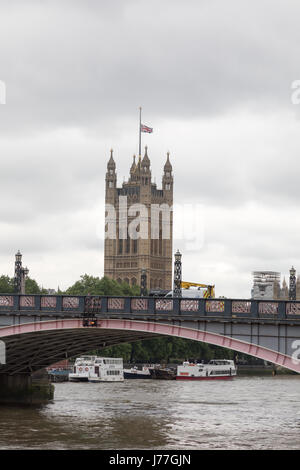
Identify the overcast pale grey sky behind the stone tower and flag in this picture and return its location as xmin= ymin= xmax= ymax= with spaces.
xmin=0 ymin=0 xmax=300 ymax=297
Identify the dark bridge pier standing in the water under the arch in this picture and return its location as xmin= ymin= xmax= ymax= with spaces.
xmin=0 ymin=374 xmax=54 ymax=405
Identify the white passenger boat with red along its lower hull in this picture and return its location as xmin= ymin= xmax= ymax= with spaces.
xmin=176 ymin=359 xmax=237 ymax=380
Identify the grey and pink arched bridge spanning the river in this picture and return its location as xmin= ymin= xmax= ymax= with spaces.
xmin=0 ymin=295 xmax=300 ymax=400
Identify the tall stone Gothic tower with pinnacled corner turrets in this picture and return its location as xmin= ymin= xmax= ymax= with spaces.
xmin=104 ymin=147 xmax=173 ymax=290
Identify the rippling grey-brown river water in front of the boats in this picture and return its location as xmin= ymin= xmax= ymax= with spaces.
xmin=0 ymin=376 xmax=300 ymax=450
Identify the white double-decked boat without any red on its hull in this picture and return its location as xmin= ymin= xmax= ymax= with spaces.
xmin=69 ymin=356 xmax=124 ymax=382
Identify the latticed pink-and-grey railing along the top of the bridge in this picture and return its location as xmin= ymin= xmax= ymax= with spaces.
xmin=0 ymin=294 xmax=300 ymax=319
